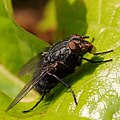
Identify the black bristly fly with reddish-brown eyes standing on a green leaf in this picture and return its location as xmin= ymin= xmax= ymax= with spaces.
xmin=6 ymin=34 xmax=113 ymax=113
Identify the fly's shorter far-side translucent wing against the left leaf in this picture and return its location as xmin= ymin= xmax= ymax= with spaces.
xmin=18 ymin=53 xmax=42 ymax=76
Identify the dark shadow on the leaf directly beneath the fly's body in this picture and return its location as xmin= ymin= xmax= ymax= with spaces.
xmin=43 ymin=56 xmax=106 ymax=107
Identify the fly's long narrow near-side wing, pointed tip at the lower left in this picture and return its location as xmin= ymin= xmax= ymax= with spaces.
xmin=6 ymin=68 xmax=51 ymax=111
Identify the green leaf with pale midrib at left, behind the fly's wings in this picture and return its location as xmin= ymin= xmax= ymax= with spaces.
xmin=0 ymin=0 xmax=49 ymax=120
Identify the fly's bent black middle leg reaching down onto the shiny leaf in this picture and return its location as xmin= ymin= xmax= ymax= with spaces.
xmin=48 ymin=73 xmax=78 ymax=105
